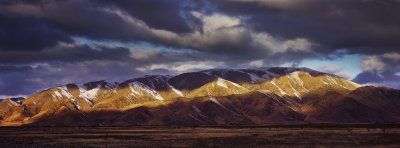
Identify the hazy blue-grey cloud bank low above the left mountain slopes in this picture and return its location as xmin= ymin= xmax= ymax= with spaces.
xmin=0 ymin=60 xmax=144 ymax=96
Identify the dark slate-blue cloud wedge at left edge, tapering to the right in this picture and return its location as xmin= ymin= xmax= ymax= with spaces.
xmin=0 ymin=14 xmax=70 ymax=51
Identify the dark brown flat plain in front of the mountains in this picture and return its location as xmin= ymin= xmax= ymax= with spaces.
xmin=0 ymin=125 xmax=400 ymax=147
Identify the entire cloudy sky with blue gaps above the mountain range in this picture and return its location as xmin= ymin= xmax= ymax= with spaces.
xmin=0 ymin=0 xmax=400 ymax=98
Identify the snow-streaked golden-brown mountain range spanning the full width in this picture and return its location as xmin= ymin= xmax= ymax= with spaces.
xmin=0 ymin=67 xmax=400 ymax=126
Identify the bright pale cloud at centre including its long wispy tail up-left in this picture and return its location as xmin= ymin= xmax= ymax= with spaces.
xmin=108 ymin=10 xmax=314 ymax=54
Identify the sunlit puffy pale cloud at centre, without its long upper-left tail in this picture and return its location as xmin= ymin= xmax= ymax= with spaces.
xmin=155 ymin=12 xmax=314 ymax=56
